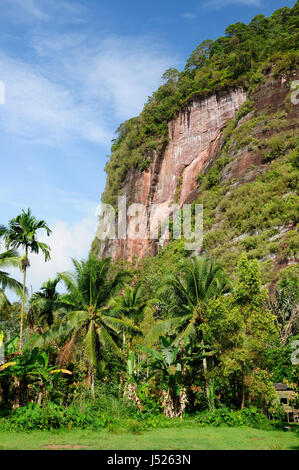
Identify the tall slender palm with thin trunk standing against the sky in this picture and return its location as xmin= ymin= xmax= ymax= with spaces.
xmin=4 ymin=209 xmax=51 ymax=352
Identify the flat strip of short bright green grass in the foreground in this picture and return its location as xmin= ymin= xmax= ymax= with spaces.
xmin=0 ymin=427 xmax=299 ymax=450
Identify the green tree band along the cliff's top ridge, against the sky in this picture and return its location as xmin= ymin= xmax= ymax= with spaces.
xmin=102 ymin=2 xmax=299 ymax=204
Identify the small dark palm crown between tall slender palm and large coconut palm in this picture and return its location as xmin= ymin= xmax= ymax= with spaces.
xmin=28 ymin=277 xmax=63 ymax=328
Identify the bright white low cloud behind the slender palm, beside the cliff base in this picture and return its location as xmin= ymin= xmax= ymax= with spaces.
xmin=0 ymin=186 xmax=99 ymax=300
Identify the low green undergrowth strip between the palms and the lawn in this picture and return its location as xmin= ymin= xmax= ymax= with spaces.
xmin=0 ymin=395 xmax=286 ymax=434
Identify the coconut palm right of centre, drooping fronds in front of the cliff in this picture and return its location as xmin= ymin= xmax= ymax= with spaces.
xmin=147 ymin=256 xmax=231 ymax=393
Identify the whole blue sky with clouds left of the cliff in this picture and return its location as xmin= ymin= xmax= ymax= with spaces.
xmin=0 ymin=0 xmax=295 ymax=298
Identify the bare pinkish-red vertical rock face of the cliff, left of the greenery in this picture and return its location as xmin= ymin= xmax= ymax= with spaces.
xmin=99 ymin=89 xmax=246 ymax=260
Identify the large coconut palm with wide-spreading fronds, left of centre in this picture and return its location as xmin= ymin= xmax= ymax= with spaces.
xmin=35 ymin=254 xmax=139 ymax=395
